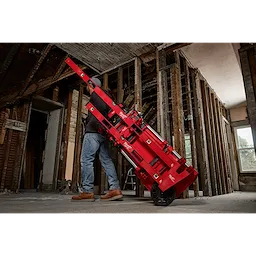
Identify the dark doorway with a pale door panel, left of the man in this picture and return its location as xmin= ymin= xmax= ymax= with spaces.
xmin=20 ymin=96 xmax=64 ymax=191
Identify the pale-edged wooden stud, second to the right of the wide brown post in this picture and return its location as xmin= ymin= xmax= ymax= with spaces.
xmin=191 ymin=69 xmax=212 ymax=196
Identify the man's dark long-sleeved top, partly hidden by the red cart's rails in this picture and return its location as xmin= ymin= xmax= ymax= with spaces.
xmin=85 ymin=90 xmax=110 ymax=133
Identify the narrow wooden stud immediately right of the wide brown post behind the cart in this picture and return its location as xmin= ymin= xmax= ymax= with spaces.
xmin=183 ymin=63 xmax=199 ymax=197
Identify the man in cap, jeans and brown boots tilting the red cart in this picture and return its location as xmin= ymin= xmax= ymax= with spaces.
xmin=72 ymin=77 xmax=123 ymax=201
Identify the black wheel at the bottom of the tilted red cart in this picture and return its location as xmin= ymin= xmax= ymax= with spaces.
xmin=150 ymin=183 xmax=176 ymax=206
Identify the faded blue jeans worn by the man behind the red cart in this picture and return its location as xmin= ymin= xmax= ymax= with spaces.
xmin=81 ymin=133 xmax=120 ymax=192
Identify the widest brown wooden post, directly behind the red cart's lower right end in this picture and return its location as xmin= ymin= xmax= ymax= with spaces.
xmin=170 ymin=52 xmax=189 ymax=198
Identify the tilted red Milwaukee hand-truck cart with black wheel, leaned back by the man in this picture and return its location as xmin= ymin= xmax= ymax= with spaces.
xmin=66 ymin=58 xmax=198 ymax=206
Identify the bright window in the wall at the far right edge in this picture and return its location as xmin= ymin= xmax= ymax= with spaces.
xmin=235 ymin=126 xmax=256 ymax=172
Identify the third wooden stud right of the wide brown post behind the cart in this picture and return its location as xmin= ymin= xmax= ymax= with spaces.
xmin=201 ymin=81 xmax=218 ymax=196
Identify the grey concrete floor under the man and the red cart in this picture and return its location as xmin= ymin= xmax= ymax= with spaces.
xmin=0 ymin=191 xmax=256 ymax=216
